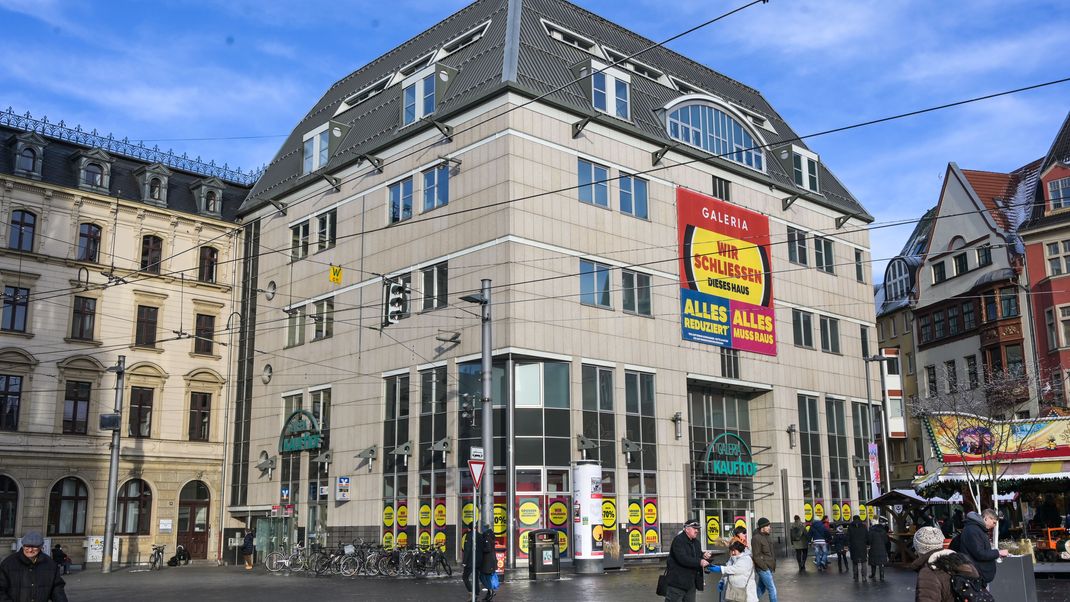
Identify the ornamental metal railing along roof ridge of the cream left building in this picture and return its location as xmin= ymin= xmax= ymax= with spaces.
xmin=0 ymin=107 xmax=264 ymax=186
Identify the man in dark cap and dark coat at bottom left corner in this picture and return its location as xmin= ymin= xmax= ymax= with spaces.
xmin=0 ymin=531 xmax=67 ymax=602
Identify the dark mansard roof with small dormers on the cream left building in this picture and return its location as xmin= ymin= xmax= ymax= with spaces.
xmin=0 ymin=125 xmax=249 ymax=221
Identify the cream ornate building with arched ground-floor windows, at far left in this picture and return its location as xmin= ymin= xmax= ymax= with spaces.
xmin=0 ymin=109 xmax=254 ymax=564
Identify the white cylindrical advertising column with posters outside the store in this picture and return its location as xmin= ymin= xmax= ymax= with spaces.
xmin=572 ymin=460 xmax=605 ymax=574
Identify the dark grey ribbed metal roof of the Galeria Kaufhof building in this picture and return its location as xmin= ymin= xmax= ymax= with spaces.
xmin=240 ymin=0 xmax=872 ymax=221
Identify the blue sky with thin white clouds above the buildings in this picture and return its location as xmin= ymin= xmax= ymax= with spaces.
xmin=0 ymin=0 xmax=1070 ymax=280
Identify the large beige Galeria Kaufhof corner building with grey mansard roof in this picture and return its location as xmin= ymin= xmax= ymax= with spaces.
xmin=229 ymin=0 xmax=878 ymax=566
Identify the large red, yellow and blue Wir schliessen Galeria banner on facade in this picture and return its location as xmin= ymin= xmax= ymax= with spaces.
xmin=676 ymin=188 xmax=777 ymax=355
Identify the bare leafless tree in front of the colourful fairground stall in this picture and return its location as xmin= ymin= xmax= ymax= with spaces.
xmin=911 ymin=369 xmax=1040 ymax=542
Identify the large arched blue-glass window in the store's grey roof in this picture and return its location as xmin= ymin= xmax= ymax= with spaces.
xmin=666 ymin=96 xmax=765 ymax=171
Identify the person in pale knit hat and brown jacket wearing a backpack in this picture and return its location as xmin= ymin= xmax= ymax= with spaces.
xmin=911 ymin=527 xmax=993 ymax=602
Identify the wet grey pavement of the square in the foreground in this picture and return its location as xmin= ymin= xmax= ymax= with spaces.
xmin=60 ymin=566 xmax=1070 ymax=602
